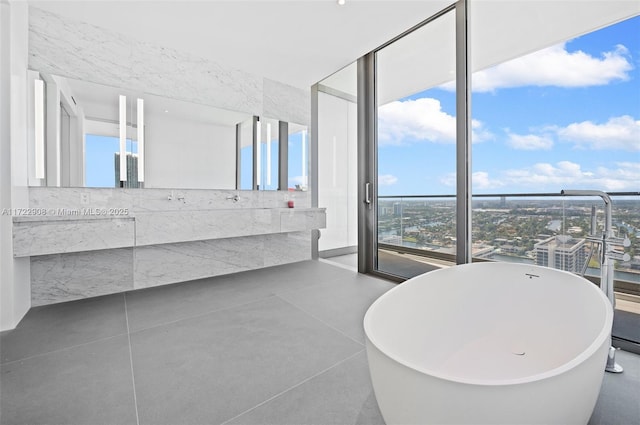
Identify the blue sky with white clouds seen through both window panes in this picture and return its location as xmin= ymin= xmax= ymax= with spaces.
xmin=378 ymin=17 xmax=640 ymax=195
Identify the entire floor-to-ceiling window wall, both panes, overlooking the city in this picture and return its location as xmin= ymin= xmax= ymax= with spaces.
xmin=338 ymin=1 xmax=640 ymax=350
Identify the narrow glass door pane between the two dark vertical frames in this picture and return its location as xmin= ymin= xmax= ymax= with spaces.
xmin=375 ymin=9 xmax=457 ymax=278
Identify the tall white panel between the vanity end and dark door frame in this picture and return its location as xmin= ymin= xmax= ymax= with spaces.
xmin=318 ymin=92 xmax=358 ymax=251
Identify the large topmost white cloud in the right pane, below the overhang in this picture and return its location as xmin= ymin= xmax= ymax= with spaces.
xmin=441 ymin=43 xmax=633 ymax=92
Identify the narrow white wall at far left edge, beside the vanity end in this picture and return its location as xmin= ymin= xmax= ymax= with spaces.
xmin=0 ymin=0 xmax=31 ymax=330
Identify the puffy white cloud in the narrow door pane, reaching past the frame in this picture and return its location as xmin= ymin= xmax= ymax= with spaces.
xmin=378 ymin=98 xmax=493 ymax=145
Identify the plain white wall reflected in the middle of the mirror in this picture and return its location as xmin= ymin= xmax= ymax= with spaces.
xmin=144 ymin=115 xmax=236 ymax=189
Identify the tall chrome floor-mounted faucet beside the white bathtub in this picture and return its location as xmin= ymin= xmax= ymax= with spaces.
xmin=560 ymin=190 xmax=631 ymax=373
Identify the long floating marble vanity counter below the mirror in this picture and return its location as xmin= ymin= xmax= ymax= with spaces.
xmin=13 ymin=207 xmax=326 ymax=257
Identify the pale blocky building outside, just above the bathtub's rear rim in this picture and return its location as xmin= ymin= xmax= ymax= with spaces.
xmin=534 ymin=235 xmax=587 ymax=273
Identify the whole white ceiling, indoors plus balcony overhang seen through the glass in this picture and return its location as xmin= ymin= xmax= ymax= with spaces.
xmin=28 ymin=0 xmax=640 ymax=103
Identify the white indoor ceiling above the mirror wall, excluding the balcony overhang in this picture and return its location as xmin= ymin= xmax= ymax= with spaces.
xmin=29 ymin=0 xmax=453 ymax=89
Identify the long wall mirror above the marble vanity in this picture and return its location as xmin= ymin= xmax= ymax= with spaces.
xmin=29 ymin=71 xmax=309 ymax=190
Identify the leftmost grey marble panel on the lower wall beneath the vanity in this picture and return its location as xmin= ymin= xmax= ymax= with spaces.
xmin=31 ymin=248 xmax=133 ymax=307
